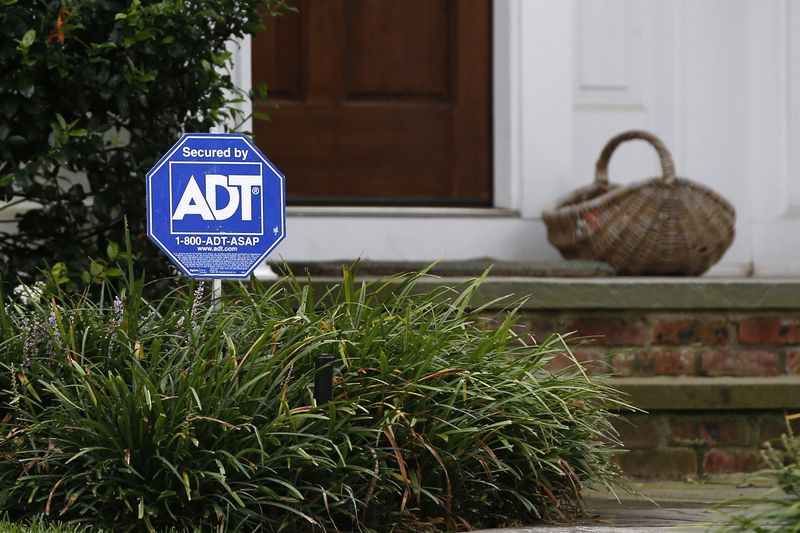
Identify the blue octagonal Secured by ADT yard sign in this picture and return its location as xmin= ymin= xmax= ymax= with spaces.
xmin=147 ymin=133 xmax=286 ymax=278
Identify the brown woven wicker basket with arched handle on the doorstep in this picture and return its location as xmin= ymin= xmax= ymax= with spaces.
xmin=542 ymin=131 xmax=736 ymax=275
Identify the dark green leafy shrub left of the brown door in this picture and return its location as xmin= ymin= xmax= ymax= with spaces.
xmin=0 ymin=0 xmax=284 ymax=288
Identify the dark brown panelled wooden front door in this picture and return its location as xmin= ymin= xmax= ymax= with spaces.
xmin=253 ymin=0 xmax=492 ymax=206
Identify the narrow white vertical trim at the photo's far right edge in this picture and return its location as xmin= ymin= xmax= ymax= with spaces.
xmin=749 ymin=0 xmax=800 ymax=276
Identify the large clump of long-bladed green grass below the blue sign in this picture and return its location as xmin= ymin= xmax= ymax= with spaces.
xmin=0 ymin=269 xmax=626 ymax=531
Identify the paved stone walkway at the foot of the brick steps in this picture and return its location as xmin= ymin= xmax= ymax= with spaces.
xmin=477 ymin=475 xmax=782 ymax=533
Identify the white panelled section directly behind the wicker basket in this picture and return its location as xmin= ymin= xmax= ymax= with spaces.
xmin=563 ymin=0 xmax=752 ymax=275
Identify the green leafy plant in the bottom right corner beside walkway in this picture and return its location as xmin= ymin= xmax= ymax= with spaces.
xmin=715 ymin=415 xmax=800 ymax=533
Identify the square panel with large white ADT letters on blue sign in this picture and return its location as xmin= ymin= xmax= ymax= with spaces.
xmin=169 ymin=161 xmax=264 ymax=235
